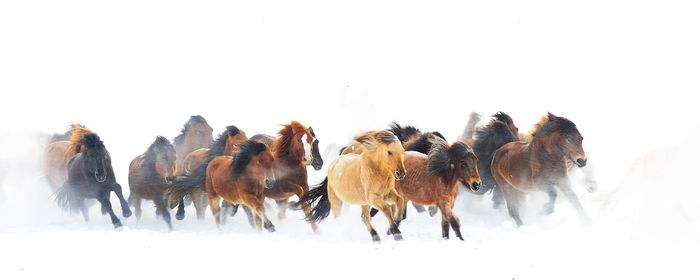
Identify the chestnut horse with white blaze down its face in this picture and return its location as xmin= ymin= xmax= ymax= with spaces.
xmin=250 ymin=121 xmax=323 ymax=231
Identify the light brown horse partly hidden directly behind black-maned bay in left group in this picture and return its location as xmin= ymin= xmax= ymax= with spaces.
xmin=175 ymin=125 xmax=248 ymax=220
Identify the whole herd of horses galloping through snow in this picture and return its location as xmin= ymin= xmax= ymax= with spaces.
xmin=44 ymin=112 xmax=595 ymax=241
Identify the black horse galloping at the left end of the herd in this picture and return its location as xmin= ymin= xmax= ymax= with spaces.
xmin=54 ymin=133 xmax=131 ymax=228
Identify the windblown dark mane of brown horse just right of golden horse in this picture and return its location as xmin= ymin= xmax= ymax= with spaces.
xmin=426 ymin=138 xmax=472 ymax=184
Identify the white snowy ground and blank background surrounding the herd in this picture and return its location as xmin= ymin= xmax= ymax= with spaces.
xmin=0 ymin=1 xmax=700 ymax=279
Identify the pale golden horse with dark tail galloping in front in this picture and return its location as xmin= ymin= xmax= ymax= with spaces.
xmin=300 ymin=130 xmax=406 ymax=242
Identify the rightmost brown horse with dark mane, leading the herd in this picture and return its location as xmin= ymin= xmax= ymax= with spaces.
xmin=491 ymin=113 xmax=590 ymax=226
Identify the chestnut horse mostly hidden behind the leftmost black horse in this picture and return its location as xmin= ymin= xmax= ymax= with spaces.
xmin=44 ymin=124 xmax=92 ymax=191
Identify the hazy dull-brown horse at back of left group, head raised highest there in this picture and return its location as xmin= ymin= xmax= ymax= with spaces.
xmin=173 ymin=115 xmax=214 ymax=220
